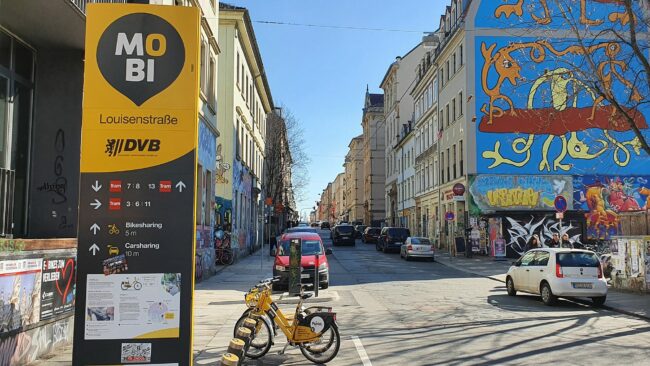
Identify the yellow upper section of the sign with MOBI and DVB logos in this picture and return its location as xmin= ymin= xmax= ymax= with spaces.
xmin=81 ymin=4 xmax=200 ymax=172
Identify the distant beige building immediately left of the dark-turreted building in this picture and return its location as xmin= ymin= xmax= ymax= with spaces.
xmin=343 ymin=135 xmax=365 ymax=223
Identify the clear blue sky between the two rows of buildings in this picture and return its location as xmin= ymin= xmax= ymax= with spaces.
xmin=224 ymin=0 xmax=449 ymax=215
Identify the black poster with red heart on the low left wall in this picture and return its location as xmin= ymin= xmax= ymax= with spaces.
xmin=41 ymin=257 xmax=77 ymax=320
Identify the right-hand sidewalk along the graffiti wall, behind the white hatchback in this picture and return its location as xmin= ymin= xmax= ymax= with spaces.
xmin=436 ymin=253 xmax=650 ymax=320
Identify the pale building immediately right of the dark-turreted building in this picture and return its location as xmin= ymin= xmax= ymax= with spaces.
xmin=380 ymin=44 xmax=424 ymax=232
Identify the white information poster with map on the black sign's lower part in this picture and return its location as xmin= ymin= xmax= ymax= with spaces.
xmin=84 ymin=273 xmax=181 ymax=339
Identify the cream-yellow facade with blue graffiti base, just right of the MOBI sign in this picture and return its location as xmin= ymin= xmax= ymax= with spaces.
xmin=216 ymin=4 xmax=273 ymax=254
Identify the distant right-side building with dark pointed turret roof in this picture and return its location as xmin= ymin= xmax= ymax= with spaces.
xmin=361 ymin=89 xmax=386 ymax=226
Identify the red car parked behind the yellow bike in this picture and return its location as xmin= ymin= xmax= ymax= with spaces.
xmin=273 ymin=232 xmax=332 ymax=289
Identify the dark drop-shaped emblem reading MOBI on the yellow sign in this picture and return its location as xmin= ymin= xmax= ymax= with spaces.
xmin=97 ymin=13 xmax=185 ymax=106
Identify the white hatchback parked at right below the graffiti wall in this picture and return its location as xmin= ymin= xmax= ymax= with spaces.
xmin=506 ymin=248 xmax=607 ymax=306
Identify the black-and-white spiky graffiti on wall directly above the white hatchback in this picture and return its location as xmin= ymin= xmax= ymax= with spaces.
xmin=503 ymin=214 xmax=583 ymax=258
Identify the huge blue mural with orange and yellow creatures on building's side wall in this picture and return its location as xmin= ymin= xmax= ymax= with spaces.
xmin=475 ymin=0 xmax=650 ymax=175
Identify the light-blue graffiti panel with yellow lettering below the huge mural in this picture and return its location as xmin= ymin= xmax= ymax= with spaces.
xmin=469 ymin=174 xmax=573 ymax=213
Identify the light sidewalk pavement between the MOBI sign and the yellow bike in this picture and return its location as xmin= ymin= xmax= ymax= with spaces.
xmin=30 ymin=251 xmax=339 ymax=366
